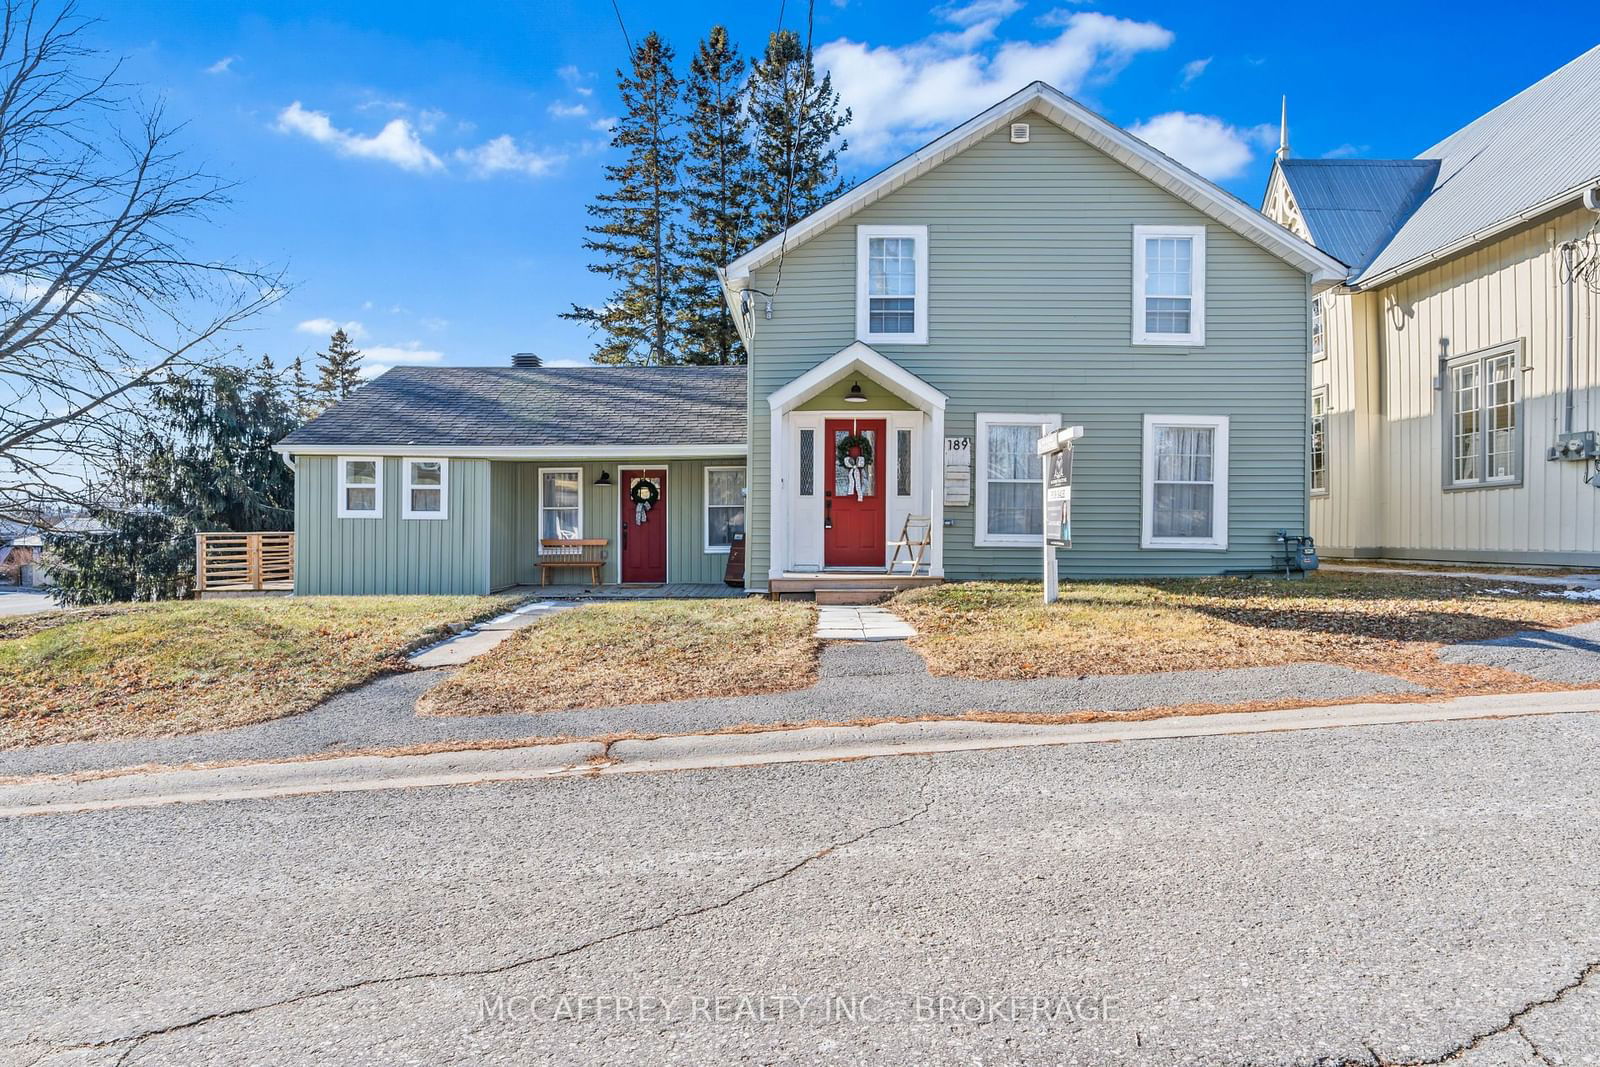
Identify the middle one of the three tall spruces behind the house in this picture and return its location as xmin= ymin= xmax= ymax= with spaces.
xmin=683 ymin=26 xmax=755 ymax=363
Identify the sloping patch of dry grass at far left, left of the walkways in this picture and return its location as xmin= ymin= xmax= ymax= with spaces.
xmin=0 ymin=597 xmax=515 ymax=749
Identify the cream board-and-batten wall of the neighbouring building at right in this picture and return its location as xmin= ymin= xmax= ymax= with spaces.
xmin=1312 ymin=208 xmax=1600 ymax=565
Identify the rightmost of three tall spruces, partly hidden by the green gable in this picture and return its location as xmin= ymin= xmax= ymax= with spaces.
xmin=750 ymin=30 xmax=850 ymax=247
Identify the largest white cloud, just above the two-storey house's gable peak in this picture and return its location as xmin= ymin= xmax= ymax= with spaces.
xmin=818 ymin=7 xmax=1173 ymax=158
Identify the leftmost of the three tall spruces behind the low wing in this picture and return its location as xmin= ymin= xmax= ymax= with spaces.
xmin=562 ymin=32 xmax=683 ymax=365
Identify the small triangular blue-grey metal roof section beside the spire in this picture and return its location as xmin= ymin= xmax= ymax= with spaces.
xmin=1277 ymin=158 xmax=1438 ymax=277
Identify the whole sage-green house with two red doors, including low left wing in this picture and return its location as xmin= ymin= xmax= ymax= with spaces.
xmin=278 ymin=83 xmax=1346 ymax=593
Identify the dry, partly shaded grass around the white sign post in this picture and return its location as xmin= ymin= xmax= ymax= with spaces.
xmin=888 ymin=574 xmax=1600 ymax=691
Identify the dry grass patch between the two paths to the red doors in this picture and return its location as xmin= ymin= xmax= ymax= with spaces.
xmin=418 ymin=600 xmax=818 ymax=715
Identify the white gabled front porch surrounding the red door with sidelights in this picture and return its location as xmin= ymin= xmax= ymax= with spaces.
xmin=766 ymin=342 xmax=946 ymax=595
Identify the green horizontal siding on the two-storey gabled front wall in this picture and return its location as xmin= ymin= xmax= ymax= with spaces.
xmin=749 ymin=115 xmax=1309 ymax=585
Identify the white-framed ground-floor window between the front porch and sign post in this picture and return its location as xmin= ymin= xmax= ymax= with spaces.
xmin=973 ymin=413 xmax=1061 ymax=547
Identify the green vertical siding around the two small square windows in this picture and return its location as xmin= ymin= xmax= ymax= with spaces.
xmin=294 ymin=456 xmax=490 ymax=595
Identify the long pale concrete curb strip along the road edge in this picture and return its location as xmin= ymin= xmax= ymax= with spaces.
xmin=0 ymin=689 xmax=1600 ymax=817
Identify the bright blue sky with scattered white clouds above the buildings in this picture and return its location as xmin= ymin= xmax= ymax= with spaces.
xmin=83 ymin=0 xmax=1600 ymax=375
